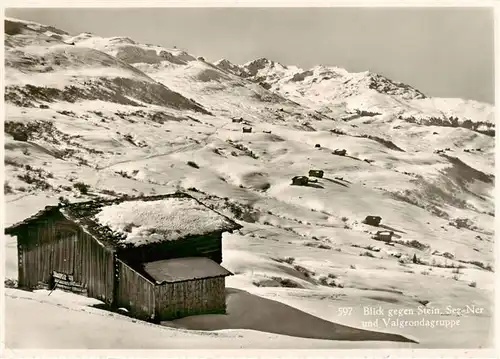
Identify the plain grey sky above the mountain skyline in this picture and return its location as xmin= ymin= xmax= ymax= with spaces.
xmin=6 ymin=8 xmax=494 ymax=103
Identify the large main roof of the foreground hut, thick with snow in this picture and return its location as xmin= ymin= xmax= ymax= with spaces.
xmin=5 ymin=192 xmax=241 ymax=247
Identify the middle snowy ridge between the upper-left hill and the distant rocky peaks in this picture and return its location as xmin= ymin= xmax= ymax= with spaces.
xmin=75 ymin=34 xmax=318 ymax=122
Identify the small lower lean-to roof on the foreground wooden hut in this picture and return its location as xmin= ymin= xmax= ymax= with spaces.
xmin=144 ymin=257 xmax=232 ymax=283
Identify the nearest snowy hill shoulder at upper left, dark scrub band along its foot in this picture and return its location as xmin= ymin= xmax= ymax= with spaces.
xmin=5 ymin=20 xmax=206 ymax=113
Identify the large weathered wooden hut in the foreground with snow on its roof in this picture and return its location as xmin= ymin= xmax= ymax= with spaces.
xmin=5 ymin=192 xmax=241 ymax=320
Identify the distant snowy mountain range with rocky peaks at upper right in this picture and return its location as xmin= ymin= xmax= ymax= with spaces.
xmin=215 ymin=58 xmax=495 ymax=134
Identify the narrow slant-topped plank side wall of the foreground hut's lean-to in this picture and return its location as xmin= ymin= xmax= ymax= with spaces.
xmin=116 ymin=259 xmax=155 ymax=319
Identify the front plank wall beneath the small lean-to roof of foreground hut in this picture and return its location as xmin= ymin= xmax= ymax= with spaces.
xmin=155 ymin=277 xmax=226 ymax=320
